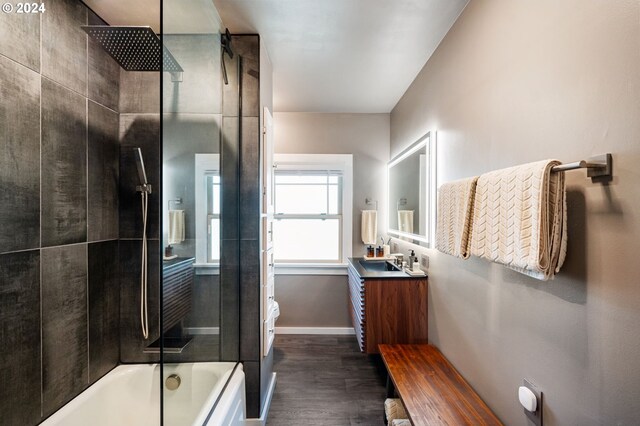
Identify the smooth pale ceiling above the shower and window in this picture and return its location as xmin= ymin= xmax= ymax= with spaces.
xmin=85 ymin=0 xmax=468 ymax=113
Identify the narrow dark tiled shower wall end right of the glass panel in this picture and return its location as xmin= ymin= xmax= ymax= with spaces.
xmin=221 ymin=35 xmax=273 ymax=418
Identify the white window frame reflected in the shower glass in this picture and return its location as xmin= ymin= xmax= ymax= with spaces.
xmin=194 ymin=154 xmax=220 ymax=275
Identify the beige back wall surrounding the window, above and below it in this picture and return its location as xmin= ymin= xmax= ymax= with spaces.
xmin=274 ymin=112 xmax=389 ymax=327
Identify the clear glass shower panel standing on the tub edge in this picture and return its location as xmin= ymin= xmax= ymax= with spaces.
xmin=161 ymin=0 xmax=238 ymax=426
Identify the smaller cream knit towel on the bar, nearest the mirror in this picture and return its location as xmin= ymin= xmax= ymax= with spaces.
xmin=436 ymin=176 xmax=478 ymax=259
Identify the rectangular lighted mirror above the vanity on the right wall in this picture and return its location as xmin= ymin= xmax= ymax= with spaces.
xmin=387 ymin=132 xmax=436 ymax=247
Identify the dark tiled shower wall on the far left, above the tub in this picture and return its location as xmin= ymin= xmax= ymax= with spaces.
xmin=0 ymin=0 xmax=120 ymax=426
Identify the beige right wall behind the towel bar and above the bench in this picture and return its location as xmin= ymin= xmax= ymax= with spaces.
xmin=391 ymin=0 xmax=640 ymax=425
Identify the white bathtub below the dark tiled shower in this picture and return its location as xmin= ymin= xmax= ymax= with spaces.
xmin=42 ymin=362 xmax=246 ymax=426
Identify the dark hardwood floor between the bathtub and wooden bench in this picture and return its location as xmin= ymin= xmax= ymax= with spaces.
xmin=267 ymin=335 xmax=386 ymax=426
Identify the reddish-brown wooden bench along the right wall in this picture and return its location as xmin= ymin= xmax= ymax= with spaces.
xmin=379 ymin=345 xmax=502 ymax=426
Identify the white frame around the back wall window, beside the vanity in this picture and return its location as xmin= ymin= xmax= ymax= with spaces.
xmin=274 ymin=154 xmax=353 ymax=275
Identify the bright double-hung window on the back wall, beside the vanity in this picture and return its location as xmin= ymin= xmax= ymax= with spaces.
xmin=273 ymin=154 xmax=352 ymax=265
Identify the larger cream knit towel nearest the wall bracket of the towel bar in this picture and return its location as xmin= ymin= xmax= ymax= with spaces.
xmin=471 ymin=160 xmax=567 ymax=281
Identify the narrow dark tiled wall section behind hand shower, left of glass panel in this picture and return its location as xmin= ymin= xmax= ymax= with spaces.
xmin=118 ymin=70 xmax=161 ymax=363
